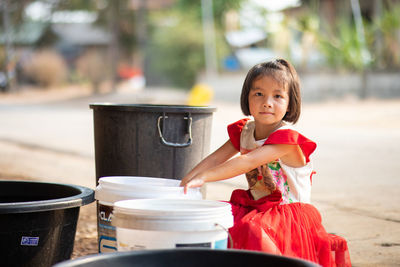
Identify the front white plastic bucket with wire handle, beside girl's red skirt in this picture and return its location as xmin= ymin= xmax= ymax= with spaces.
xmin=113 ymin=199 xmax=233 ymax=251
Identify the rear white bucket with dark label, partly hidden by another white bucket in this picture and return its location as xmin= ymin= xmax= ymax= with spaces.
xmin=95 ymin=176 xmax=202 ymax=253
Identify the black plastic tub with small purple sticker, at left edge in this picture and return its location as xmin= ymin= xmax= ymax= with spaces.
xmin=0 ymin=181 xmax=94 ymax=267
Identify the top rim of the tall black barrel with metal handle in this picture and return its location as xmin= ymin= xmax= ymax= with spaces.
xmin=89 ymin=103 xmax=217 ymax=113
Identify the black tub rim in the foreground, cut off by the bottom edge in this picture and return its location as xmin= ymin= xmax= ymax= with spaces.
xmin=54 ymin=249 xmax=319 ymax=267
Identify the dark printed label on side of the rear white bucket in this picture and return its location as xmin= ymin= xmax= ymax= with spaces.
xmin=97 ymin=204 xmax=117 ymax=253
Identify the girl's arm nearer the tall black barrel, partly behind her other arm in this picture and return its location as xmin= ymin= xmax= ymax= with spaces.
xmin=181 ymin=140 xmax=238 ymax=186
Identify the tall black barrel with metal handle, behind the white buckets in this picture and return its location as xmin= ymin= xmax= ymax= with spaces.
xmin=90 ymin=103 xmax=216 ymax=185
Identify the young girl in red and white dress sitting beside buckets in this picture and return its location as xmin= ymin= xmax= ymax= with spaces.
xmin=181 ymin=59 xmax=351 ymax=266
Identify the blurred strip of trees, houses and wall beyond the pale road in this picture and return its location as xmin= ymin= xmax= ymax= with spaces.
xmin=0 ymin=0 xmax=400 ymax=100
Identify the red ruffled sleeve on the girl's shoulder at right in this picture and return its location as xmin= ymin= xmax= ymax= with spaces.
xmin=264 ymin=129 xmax=317 ymax=162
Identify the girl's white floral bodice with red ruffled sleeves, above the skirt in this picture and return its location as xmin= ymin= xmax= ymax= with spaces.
xmin=228 ymin=119 xmax=316 ymax=204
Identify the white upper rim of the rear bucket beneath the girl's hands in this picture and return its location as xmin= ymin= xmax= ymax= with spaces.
xmin=95 ymin=176 xmax=202 ymax=205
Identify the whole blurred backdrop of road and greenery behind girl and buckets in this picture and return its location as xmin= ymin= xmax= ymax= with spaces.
xmin=0 ymin=0 xmax=400 ymax=266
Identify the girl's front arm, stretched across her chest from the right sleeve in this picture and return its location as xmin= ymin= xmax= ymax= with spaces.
xmin=181 ymin=144 xmax=297 ymax=192
